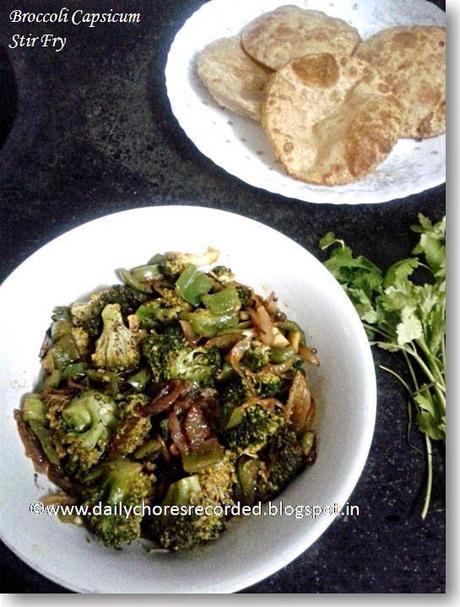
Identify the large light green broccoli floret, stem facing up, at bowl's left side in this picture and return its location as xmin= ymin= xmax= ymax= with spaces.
xmin=47 ymin=390 xmax=118 ymax=477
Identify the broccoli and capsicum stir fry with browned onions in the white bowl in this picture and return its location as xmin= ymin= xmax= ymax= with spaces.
xmin=16 ymin=249 xmax=319 ymax=550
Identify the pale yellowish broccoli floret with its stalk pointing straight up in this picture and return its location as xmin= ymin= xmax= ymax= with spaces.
xmin=91 ymin=304 xmax=140 ymax=371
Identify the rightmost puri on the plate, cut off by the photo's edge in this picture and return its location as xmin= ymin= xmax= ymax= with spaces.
xmin=355 ymin=26 xmax=446 ymax=139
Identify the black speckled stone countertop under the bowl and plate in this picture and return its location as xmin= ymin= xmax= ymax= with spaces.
xmin=0 ymin=0 xmax=445 ymax=593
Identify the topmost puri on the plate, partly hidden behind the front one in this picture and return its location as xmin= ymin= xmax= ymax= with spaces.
xmin=241 ymin=6 xmax=360 ymax=70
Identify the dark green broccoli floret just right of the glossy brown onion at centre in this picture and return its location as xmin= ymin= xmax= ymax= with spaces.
xmin=226 ymin=404 xmax=284 ymax=453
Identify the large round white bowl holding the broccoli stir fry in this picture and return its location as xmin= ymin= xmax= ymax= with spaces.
xmin=0 ymin=206 xmax=376 ymax=593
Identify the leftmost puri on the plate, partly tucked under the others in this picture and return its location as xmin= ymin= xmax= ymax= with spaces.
xmin=197 ymin=36 xmax=271 ymax=121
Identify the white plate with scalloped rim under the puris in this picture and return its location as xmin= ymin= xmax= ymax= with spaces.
xmin=166 ymin=0 xmax=446 ymax=204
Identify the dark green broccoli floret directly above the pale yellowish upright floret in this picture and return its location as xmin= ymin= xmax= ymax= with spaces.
xmin=70 ymin=285 xmax=148 ymax=337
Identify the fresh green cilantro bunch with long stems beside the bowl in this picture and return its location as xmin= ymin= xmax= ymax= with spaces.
xmin=319 ymin=214 xmax=446 ymax=518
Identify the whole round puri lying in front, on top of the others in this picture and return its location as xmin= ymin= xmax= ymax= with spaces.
xmin=262 ymin=53 xmax=401 ymax=185
